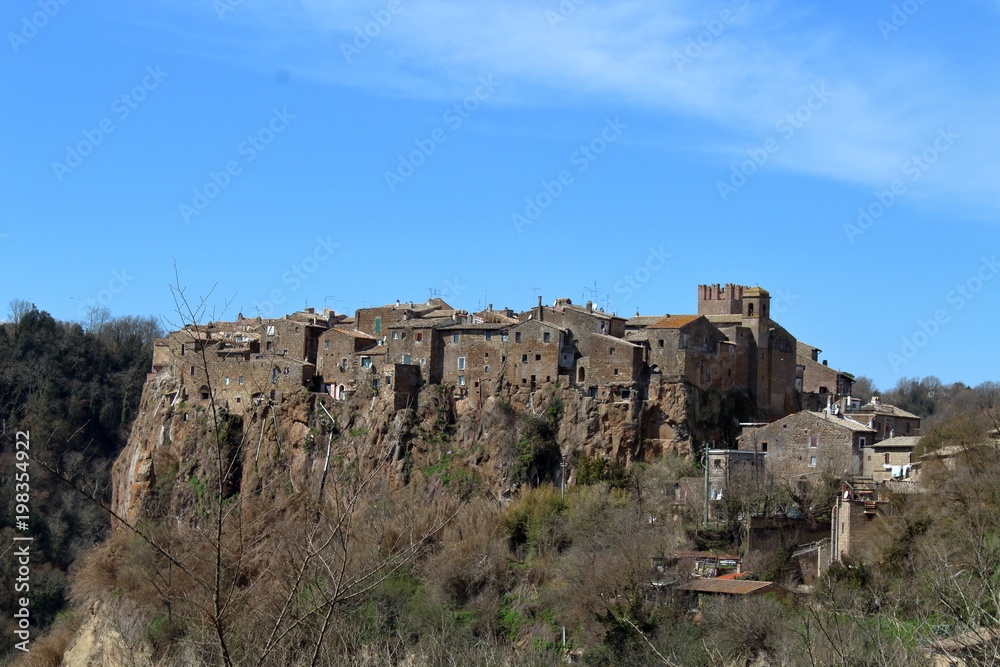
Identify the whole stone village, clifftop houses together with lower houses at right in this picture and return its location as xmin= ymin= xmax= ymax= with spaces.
xmin=151 ymin=284 xmax=936 ymax=564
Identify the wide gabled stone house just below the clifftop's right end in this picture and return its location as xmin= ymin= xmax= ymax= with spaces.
xmin=737 ymin=411 xmax=875 ymax=482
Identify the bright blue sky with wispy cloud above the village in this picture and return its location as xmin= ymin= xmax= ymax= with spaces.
xmin=0 ymin=0 xmax=1000 ymax=387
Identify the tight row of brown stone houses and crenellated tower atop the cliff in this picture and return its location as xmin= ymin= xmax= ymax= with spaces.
xmin=153 ymin=284 xmax=853 ymax=420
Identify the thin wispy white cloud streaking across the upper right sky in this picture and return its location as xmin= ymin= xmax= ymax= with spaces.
xmin=156 ymin=0 xmax=1000 ymax=214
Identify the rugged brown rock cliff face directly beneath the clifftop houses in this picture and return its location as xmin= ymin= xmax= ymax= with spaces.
xmin=113 ymin=375 xmax=742 ymax=523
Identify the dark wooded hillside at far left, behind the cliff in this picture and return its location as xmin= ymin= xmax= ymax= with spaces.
xmin=0 ymin=302 xmax=160 ymax=655
